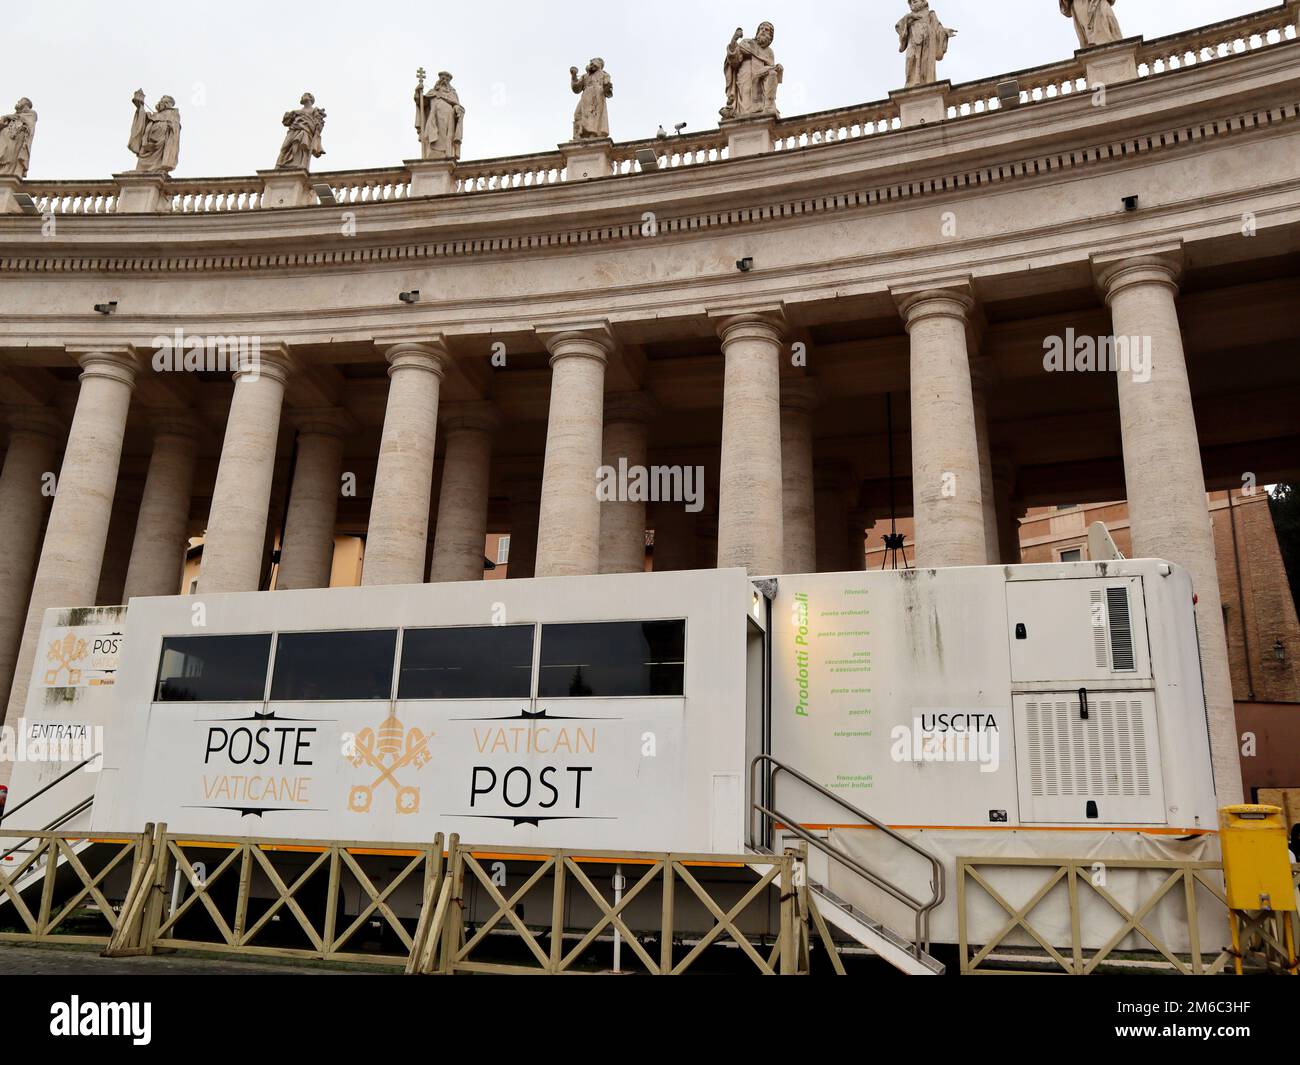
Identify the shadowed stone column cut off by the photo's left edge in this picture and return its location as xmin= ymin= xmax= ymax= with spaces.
xmin=0 ymin=407 xmax=64 ymax=717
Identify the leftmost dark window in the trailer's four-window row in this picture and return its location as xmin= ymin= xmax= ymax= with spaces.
xmin=153 ymin=633 xmax=270 ymax=702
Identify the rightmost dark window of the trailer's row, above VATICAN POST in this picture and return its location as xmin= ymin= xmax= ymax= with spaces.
xmin=537 ymin=622 xmax=686 ymax=698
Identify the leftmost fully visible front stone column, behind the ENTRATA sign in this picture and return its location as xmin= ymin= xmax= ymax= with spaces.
xmin=0 ymin=347 xmax=138 ymax=733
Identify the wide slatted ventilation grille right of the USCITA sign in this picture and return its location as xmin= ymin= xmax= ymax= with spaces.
xmin=1024 ymin=692 xmax=1151 ymax=798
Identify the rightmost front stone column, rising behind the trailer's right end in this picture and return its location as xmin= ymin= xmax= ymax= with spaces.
xmin=1093 ymin=246 xmax=1242 ymax=806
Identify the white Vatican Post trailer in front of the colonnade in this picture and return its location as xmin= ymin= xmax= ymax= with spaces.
xmin=0 ymin=559 xmax=1217 ymax=957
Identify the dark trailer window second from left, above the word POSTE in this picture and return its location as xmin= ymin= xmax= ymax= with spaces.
xmin=270 ymin=628 xmax=398 ymax=702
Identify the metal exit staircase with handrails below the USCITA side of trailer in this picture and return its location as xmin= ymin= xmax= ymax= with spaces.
xmin=749 ymin=754 xmax=945 ymax=977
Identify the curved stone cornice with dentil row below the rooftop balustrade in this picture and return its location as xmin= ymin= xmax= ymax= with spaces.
xmin=0 ymin=44 xmax=1300 ymax=274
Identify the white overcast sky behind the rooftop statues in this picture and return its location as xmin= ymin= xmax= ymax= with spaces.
xmin=0 ymin=0 xmax=1274 ymax=178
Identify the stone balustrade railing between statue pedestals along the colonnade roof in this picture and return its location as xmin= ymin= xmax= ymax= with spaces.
xmin=7 ymin=0 xmax=1300 ymax=216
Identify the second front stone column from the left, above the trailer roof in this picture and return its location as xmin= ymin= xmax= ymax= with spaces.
xmin=199 ymin=345 xmax=293 ymax=594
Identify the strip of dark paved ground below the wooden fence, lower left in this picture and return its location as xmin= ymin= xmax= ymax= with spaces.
xmin=0 ymin=943 xmax=387 ymax=977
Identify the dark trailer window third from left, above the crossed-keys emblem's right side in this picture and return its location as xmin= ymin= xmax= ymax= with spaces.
xmin=398 ymin=625 xmax=533 ymax=698
